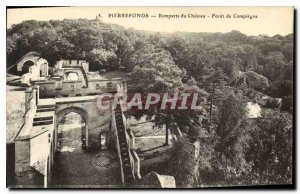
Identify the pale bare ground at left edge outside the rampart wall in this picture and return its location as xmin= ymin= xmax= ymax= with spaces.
xmin=6 ymin=86 xmax=25 ymax=143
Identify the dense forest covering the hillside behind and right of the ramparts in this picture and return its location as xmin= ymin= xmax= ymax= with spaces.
xmin=7 ymin=19 xmax=294 ymax=187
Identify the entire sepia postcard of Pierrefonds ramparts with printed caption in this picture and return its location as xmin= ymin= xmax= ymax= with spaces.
xmin=3 ymin=7 xmax=295 ymax=189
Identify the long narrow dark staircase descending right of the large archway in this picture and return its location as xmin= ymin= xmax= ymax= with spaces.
xmin=115 ymin=105 xmax=134 ymax=186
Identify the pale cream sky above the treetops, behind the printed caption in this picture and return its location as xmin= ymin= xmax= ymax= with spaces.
xmin=7 ymin=7 xmax=294 ymax=36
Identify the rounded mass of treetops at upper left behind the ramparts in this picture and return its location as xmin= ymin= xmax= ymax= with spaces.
xmin=7 ymin=19 xmax=133 ymax=69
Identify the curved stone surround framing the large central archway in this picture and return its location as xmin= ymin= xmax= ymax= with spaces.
xmin=55 ymin=106 xmax=89 ymax=149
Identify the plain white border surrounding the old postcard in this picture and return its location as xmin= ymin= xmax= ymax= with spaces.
xmin=0 ymin=0 xmax=300 ymax=193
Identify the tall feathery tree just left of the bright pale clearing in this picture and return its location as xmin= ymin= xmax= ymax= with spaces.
xmin=214 ymin=94 xmax=250 ymax=182
